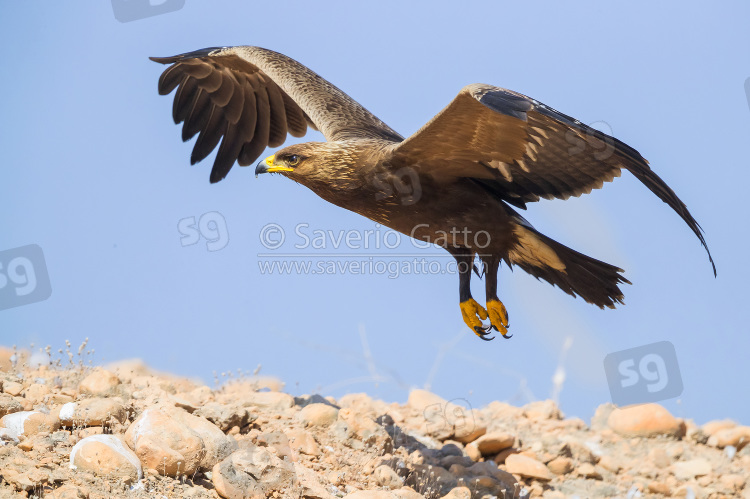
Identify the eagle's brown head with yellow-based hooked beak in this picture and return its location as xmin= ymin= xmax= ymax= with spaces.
xmin=255 ymin=142 xmax=362 ymax=188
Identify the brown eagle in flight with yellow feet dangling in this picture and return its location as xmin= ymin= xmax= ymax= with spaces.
xmin=151 ymin=46 xmax=716 ymax=340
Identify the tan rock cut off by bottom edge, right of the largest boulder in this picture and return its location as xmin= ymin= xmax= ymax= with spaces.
xmin=211 ymin=446 xmax=296 ymax=499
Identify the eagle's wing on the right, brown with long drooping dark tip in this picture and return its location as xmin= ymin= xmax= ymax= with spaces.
xmin=393 ymin=84 xmax=716 ymax=274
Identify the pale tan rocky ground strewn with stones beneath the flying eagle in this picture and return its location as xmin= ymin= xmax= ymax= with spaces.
xmin=0 ymin=348 xmax=750 ymax=499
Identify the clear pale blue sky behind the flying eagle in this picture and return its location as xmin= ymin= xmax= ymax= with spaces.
xmin=0 ymin=0 xmax=750 ymax=423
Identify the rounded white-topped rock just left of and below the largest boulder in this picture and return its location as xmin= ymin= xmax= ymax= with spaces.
xmin=70 ymin=435 xmax=143 ymax=484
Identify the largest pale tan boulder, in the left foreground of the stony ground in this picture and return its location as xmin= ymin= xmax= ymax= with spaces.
xmin=125 ymin=407 xmax=237 ymax=477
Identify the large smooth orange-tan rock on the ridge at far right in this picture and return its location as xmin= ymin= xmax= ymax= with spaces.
xmin=607 ymin=404 xmax=685 ymax=437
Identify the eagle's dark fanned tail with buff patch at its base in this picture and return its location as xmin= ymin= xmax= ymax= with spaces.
xmin=505 ymin=225 xmax=630 ymax=308
